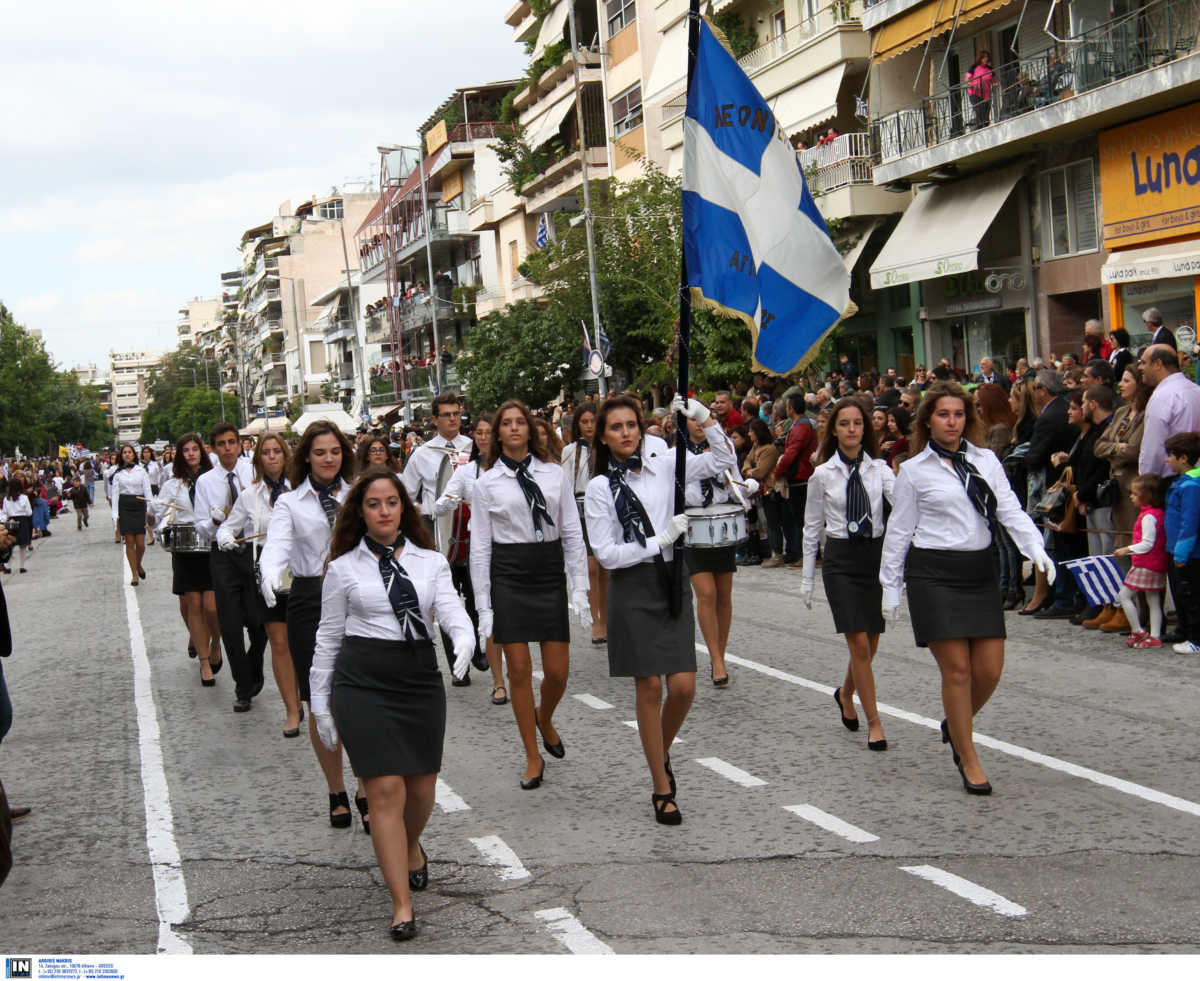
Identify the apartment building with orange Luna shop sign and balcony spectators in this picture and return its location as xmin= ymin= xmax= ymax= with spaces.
xmin=862 ymin=0 xmax=1200 ymax=369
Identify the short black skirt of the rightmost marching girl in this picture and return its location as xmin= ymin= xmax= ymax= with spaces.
xmin=905 ymin=548 xmax=1007 ymax=648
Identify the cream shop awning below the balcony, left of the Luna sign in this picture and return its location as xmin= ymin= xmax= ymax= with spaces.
xmin=871 ymin=165 xmax=1024 ymax=289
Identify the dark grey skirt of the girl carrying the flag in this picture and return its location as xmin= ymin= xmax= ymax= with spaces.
xmin=608 ymin=562 xmax=696 ymax=678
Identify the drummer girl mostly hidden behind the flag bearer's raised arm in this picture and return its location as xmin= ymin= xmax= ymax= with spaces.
xmin=683 ymin=410 xmax=758 ymax=688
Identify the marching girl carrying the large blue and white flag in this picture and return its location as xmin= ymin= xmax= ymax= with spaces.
xmin=584 ymin=395 xmax=736 ymax=824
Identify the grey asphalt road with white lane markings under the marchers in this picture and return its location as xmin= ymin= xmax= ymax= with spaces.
xmin=0 ymin=512 xmax=1200 ymax=953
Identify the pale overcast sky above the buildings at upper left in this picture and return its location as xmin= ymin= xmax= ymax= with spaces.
xmin=0 ymin=0 xmax=527 ymax=367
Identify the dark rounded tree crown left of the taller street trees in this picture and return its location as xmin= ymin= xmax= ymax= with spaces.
xmin=456 ymin=300 xmax=583 ymax=413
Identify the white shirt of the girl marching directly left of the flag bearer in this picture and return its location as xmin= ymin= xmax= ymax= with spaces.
xmin=470 ymin=458 xmax=588 ymax=609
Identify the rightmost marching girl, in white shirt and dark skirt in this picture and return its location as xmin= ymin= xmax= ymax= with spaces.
xmin=880 ymin=381 xmax=1055 ymax=794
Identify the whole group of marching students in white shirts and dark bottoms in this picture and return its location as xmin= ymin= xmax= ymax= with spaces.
xmin=106 ymin=383 xmax=1070 ymax=940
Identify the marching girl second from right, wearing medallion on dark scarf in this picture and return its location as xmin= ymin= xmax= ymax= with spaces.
xmin=800 ymin=398 xmax=895 ymax=751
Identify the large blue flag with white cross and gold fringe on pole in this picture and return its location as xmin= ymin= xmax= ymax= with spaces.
xmin=683 ymin=22 xmax=854 ymax=374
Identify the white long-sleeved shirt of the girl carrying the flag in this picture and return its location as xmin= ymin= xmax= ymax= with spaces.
xmin=583 ymin=425 xmax=737 ymax=570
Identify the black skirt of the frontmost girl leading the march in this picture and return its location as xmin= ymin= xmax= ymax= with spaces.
xmin=330 ymin=637 xmax=446 ymax=777
